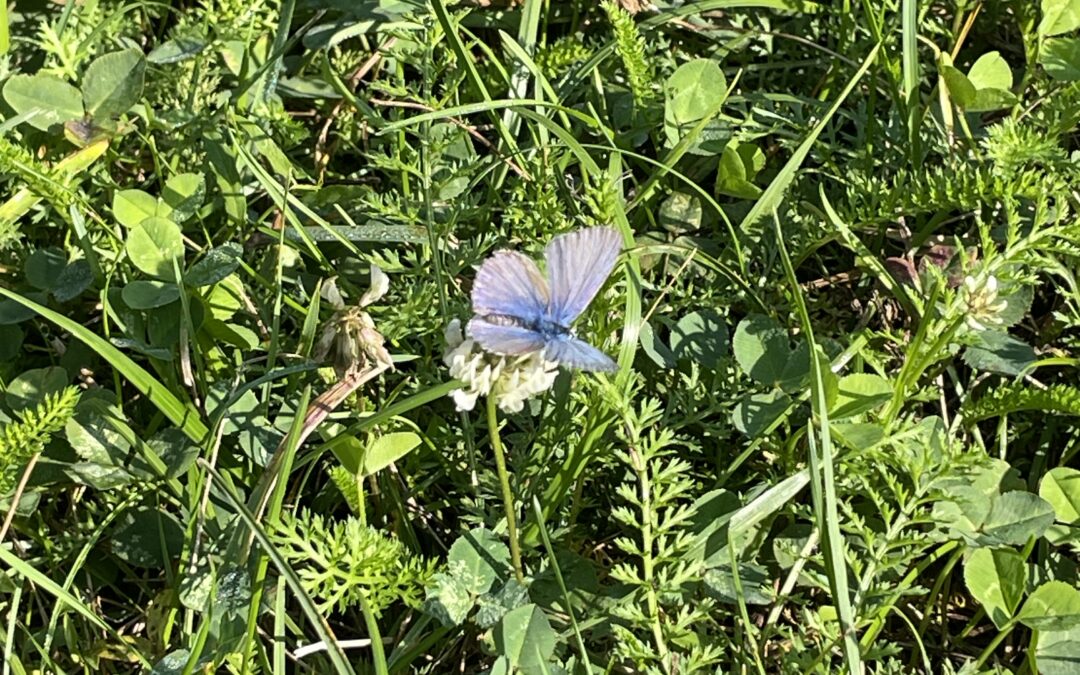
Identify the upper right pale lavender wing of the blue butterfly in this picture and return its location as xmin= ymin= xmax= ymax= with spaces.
xmin=544 ymin=227 xmax=622 ymax=327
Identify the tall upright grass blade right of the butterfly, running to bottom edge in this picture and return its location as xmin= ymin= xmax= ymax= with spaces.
xmin=773 ymin=213 xmax=863 ymax=675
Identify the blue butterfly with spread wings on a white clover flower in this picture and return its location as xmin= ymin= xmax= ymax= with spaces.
xmin=469 ymin=227 xmax=622 ymax=372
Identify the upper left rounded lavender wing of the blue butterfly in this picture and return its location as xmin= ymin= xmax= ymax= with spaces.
xmin=472 ymin=251 xmax=548 ymax=323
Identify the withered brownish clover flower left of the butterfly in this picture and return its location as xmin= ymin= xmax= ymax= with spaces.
xmin=315 ymin=265 xmax=393 ymax=378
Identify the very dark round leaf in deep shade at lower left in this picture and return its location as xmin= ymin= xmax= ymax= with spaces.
xmin=109 ymin=508 xmax=184 ymax=569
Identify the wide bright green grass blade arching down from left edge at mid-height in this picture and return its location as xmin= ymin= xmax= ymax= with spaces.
xmin=0 ymin=287 xmax=207 ymax=445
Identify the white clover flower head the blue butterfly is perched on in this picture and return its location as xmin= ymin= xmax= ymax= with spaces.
xmin=443 ymin=319 xmax=558 ymax=413
